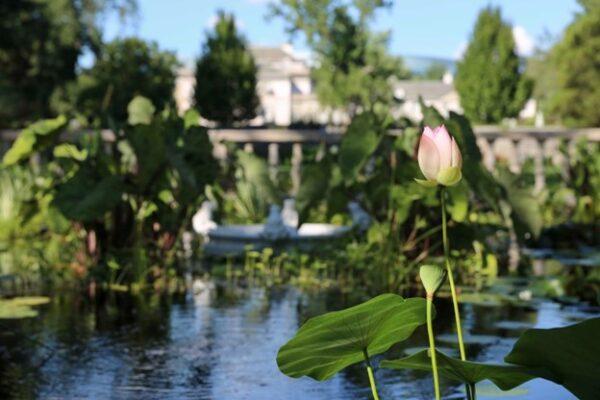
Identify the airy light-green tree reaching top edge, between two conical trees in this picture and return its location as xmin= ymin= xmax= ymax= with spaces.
xmin=272 ymin=0 xmax=409 ymax=116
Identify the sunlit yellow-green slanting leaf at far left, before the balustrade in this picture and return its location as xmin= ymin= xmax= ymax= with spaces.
xmin=2 ymin=115 xmax=68 ymax=166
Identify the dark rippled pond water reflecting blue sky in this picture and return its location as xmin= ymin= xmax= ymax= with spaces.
xmin=0 ymin=285 xmax=598 ymax=400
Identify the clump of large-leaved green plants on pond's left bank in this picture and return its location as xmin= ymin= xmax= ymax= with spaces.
xmin=2 ymin=98 xmax=217 ymax=282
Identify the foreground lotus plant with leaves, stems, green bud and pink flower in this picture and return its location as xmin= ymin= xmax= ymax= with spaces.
xmin=277 ymin=122 xmax=600 ymax=400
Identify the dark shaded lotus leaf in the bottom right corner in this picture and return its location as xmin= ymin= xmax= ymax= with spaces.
xmin=504 ymin=318 xmax=600 ymax=400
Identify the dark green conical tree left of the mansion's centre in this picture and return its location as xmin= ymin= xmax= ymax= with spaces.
xmin=194 ymin=11 xmax=259 ymax=126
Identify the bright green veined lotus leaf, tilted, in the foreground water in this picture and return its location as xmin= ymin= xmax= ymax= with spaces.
xmin=277 ymin=294 xmax=426 ymax=381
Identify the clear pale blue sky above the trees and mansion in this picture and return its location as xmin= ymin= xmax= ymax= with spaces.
xmin=105 ymin=0 xmax=579 ymax=60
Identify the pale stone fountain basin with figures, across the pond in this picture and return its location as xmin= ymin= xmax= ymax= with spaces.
xmin=193 ymin=199 xmax=370 ymax=256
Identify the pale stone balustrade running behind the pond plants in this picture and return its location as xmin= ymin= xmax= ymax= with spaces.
xmin=0 ymin=126 xmax=600 ymax=193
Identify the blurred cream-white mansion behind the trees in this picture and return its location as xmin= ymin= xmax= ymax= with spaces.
xmin=175 ymin=44 xmax=536 ymax=126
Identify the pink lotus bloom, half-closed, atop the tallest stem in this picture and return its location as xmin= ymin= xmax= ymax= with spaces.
xmin=417 ymin=125 xmax=462 ymax=186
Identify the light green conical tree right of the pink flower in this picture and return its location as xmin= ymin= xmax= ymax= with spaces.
xmin=455 ymin=7 xmax=533 ymax=123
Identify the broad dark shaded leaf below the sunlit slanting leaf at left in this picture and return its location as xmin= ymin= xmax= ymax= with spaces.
xmin=53 ymin=165 xmax=124 ymax=222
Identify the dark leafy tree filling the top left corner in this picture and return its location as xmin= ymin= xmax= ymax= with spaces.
xmin=0 ymin=0 xmax=136 ymax=126
